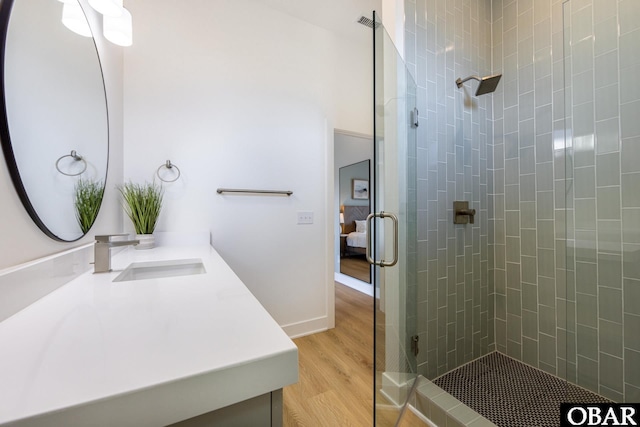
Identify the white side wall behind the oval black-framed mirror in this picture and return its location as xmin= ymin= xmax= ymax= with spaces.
xmin=0 ymin=0 xmax=122 ymax=272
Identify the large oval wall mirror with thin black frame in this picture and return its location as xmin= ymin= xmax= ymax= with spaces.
xmin=0 ymin=0 xmax=109 ymax=241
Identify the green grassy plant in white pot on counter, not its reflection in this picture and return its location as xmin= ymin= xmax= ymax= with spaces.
xmin=118 ymin=182 xmax=163 ymax=249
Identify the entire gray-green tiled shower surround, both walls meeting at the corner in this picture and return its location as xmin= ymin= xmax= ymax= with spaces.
xmin=405 ymin=0 xmax=640 ymax=401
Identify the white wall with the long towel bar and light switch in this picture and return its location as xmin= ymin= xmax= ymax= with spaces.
xmin=124 ymin=0 xmax=372 ymax=336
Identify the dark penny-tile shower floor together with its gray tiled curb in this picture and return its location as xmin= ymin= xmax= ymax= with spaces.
xmin=416 ymin=352 xmax=611 ymax=427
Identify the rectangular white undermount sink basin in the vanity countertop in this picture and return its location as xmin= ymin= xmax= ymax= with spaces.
xmin=113 ymin=258 xmax=207 ymax=282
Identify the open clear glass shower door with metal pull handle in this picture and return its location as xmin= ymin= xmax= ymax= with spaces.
xmin=367 ymin=12 xmax=420 ymax=426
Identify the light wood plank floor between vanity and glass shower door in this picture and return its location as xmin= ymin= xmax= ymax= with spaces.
xmin=284 ymin=283 xmax=373 ymax=427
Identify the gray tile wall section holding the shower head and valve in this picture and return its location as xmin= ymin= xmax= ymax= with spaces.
xmin=405 ymin=0 xmax=492 ymax=378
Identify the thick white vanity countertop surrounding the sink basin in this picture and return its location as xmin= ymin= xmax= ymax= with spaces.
xmin=0 ymin=246 xmax=298 ymax=427
